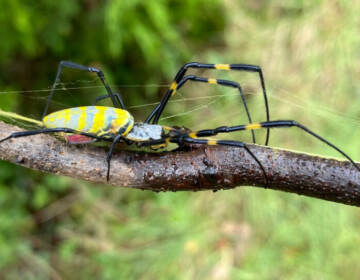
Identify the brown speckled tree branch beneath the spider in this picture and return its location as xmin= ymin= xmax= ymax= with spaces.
xmin=0 ymin=122 xmax=360 ymax=206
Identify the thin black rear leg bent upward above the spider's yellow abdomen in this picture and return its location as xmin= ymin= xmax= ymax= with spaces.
xmin=43 ymin=61 xmax=125 ymax=118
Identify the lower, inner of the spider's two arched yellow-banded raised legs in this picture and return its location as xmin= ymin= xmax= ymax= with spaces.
xmin=148 ymin=75 xmax=256 ymax=143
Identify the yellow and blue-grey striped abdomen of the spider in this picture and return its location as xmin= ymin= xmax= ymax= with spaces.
xmin=43 ymin=106 xmax=134 ymax=136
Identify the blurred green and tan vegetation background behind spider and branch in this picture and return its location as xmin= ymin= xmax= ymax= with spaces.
xmin=0 ymin=0 xmax=360 ymax=279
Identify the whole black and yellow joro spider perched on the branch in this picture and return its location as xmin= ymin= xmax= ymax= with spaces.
xmin=0 ymin=61 xmax=360 ymax=186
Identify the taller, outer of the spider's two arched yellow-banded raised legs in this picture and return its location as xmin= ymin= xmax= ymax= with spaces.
xmin=145 ymin=62 xmax=270 ymax=145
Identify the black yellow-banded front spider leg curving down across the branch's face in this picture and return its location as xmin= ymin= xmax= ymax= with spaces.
xmin=170 ymin=135 xmax=269 ymax=187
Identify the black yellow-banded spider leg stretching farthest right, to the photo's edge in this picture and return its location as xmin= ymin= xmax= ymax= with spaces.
xmin=189 ymin=120 xmax=360 ymax=171
